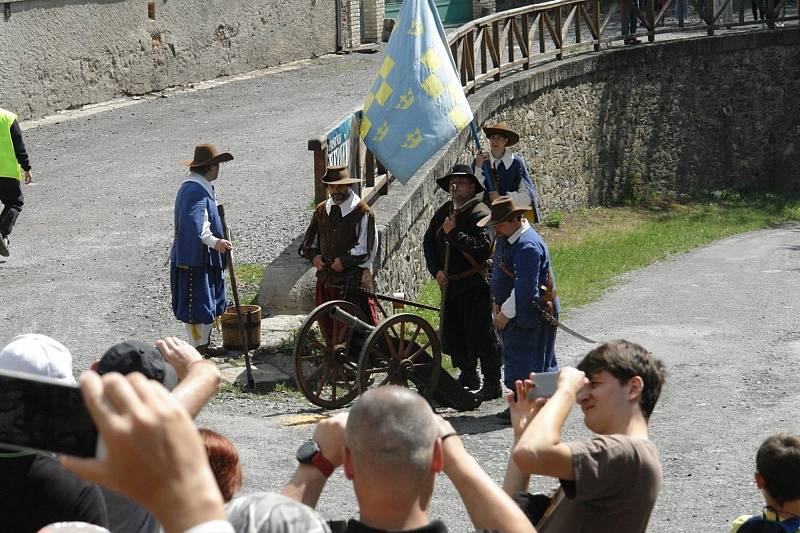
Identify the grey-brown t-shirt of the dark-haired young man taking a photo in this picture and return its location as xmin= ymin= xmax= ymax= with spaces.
xmin=536 ymin=435 xmax=661 ymax=533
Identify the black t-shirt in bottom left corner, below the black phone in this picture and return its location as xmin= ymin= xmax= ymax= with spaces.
xmin=0 ymin=454 xmax=108 ymax=533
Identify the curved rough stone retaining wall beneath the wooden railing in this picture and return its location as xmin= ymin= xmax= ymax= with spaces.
xmin=261 ymin=28 xmax=800 ymax=312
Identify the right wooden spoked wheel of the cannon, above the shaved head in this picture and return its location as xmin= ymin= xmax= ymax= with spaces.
xmin=358 ymin=313 xmax=442 ymax=402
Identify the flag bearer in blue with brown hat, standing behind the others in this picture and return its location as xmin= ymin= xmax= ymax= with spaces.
xmin=472 ymin=122 xmax=539 ymax=223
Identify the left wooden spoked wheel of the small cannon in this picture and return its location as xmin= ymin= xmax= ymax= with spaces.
xmin=293 ymin=300 xmax=368 ymax=409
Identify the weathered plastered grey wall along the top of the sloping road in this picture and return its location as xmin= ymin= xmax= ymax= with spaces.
xmin=0 ymin=0 xmax=336 ymax=118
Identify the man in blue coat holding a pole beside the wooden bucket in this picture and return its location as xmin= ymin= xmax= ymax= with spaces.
xmin=170 ymin=144 xmax=233 ymax=355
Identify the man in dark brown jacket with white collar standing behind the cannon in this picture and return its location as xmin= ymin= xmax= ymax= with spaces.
xmin=300 ymin=167 xmax=378 ymax=325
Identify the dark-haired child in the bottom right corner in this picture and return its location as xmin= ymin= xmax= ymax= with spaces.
xmin=731 ymin=433 xmax=800 ymax=533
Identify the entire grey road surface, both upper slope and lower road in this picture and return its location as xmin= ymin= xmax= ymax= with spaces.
xmin=0 ymin=42 xmax=800 ymax=532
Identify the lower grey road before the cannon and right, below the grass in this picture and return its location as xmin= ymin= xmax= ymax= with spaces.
xmin=194 ymin=225 xmax=800 ymax=533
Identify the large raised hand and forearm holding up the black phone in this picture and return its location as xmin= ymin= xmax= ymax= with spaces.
xmin=61 ymin=372 xmax=234 ymax=533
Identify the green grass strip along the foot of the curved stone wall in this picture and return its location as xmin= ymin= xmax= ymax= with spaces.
xmin=409 ymin=195 xmax=800 ymax=320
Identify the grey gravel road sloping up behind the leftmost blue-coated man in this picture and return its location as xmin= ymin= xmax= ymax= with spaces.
xmin=0 ymin=53 xmax=380 ymax=362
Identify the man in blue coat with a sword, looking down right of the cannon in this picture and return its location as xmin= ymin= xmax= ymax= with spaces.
xmin=478 ymin=196 xmax=559 ymax=420
